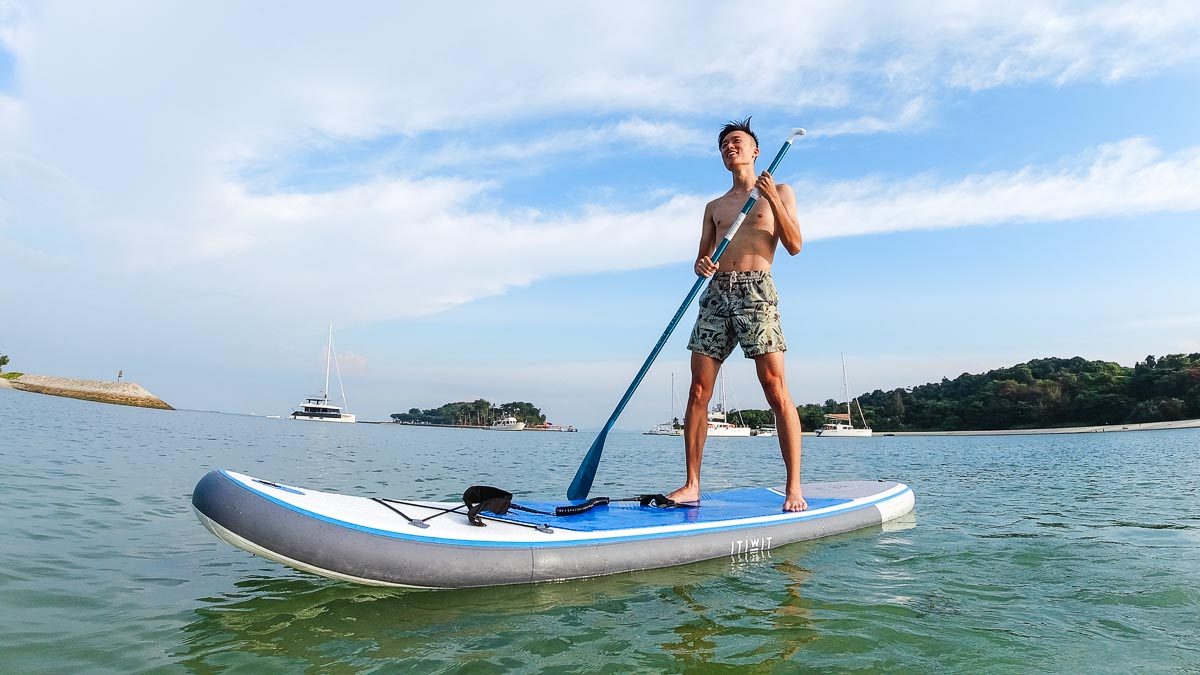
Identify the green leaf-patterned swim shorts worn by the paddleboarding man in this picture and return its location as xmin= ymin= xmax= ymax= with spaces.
xmin=688 ymin=271 xmax=787 ymax=362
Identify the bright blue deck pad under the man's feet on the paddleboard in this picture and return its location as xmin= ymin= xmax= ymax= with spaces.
xmin=492 ymin=488 xmax=851 ymax=532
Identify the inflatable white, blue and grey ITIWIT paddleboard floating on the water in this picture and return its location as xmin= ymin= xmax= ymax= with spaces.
xmin=192 ymin=471 xmax=914 ymax=589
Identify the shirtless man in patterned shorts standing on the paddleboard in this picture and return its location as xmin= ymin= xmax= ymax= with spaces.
xmin=667 ymin=118 xmax=808 ymax=510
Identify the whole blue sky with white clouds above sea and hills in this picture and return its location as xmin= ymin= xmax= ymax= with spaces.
xmin=0 ymin=0 xmax=1200 ymax=430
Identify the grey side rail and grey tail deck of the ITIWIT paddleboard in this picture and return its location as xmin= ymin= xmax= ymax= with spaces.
xmin=192 ymin=471 xmax=896 ymax=589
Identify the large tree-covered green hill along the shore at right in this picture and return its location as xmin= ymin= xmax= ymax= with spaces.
xmin=739 ymin=353 xmax=1200 ymax=432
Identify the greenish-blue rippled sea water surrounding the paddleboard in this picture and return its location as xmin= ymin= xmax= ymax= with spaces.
xmin=0 ymin=389 xmax=1200 ymax=673
